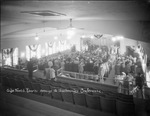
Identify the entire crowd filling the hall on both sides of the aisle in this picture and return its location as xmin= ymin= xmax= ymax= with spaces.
xmin=21 ymin=40 xmax=148 ymax=97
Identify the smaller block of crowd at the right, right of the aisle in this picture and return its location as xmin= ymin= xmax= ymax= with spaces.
xmin=115 ymin=46 xmax=148 ymax=98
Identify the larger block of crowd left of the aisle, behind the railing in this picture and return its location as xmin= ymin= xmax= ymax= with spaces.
xmin=38 ymin=46 xmax=118 ymax=81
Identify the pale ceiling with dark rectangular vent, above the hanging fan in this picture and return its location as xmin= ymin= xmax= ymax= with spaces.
xmin=1 ymin=0 xmax=150 ymax=39
